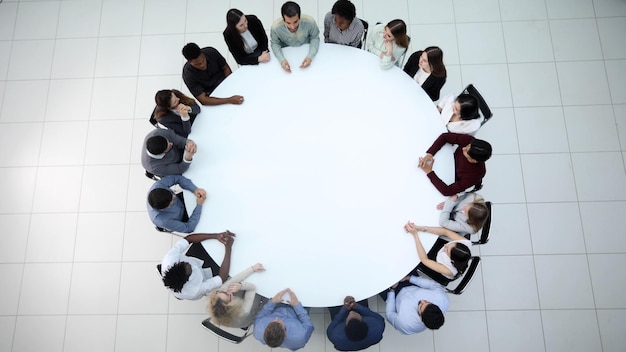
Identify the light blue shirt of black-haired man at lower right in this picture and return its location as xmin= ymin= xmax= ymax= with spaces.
xmin=385 ymin=276 xmax=448 ymax=335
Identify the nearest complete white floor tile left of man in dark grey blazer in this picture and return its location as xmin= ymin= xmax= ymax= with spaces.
xmin=85 ymin=120 xmax=133 ymax=165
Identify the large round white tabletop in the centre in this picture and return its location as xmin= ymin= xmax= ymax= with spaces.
xmin=185 ymin=44 xmax=454 ymax=307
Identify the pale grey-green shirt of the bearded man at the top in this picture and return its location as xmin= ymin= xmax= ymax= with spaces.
xmin=270 ymin=15 xmax=320 ymax=62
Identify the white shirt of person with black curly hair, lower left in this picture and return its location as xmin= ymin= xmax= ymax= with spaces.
xmin=161 ymin=238 xmax=222 ymax=300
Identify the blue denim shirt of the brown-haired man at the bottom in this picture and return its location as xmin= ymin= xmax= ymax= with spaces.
xmin=254 ymin=300 xmax=314 ymax=351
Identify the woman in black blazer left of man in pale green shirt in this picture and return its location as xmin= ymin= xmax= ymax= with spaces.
xmin=223 ymin=9 xmax=270 ymax=65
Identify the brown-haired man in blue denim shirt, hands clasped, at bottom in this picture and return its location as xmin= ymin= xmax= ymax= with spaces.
xmin=254 ymin=288 xmax=314 ymax=351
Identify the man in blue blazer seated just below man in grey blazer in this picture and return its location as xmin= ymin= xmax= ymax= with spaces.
xmin=147 ymin=175 xmax=206 ymax=233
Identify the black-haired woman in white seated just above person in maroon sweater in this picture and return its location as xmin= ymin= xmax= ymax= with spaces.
xmin=437 ymin=93 xmax=483 ymax=136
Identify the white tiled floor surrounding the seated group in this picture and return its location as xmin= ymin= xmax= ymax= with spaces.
xmin=0 ymin=0 xmax=626 ymax=352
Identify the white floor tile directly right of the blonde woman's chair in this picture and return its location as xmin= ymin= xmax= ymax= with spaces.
xmin=479 ymin=204 xmax=533 ymax=255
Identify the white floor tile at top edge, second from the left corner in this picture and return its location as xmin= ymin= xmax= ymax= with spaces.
xmin=13 ymin=1 xmax=60 ymax=40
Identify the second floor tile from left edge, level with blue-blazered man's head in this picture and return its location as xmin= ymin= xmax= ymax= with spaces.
xmin=33 ymin=166 xmax=83 ymax=212
